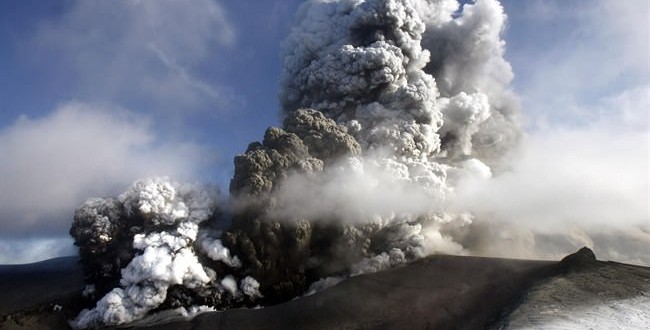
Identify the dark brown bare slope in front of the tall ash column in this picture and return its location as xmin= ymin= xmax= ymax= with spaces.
xmin=130 ymin=256 xmax=557 ymax=329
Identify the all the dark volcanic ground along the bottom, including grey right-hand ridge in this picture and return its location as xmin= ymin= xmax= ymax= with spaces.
xmin=0 ymin=249 xmax=650 ymax=330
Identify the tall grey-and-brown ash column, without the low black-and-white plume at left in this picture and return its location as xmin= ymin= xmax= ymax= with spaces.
xmin=224 ymin=1 xmax=519 ymax=301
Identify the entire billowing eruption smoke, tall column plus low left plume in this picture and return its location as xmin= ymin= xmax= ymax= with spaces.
xmin=71 ymin=0 xmax=519 ymax=328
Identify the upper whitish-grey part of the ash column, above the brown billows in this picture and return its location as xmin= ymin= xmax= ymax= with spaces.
xmin=280 ymin=0 xmax=519 ymax=168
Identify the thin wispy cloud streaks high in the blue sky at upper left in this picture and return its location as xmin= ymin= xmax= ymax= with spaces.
xmin=31 ymin=0 xmax=235 ymax=111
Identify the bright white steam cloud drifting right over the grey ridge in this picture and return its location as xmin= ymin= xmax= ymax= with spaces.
xmin=448 ymin=86 xmax=650 ymax=265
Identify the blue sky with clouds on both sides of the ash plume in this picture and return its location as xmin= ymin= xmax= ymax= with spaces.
xmin=0 ymin=0 xmax=650 ymax=263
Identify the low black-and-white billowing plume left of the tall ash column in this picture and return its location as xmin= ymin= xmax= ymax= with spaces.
xmin=70 ymin=178 xmax=259 ymax=328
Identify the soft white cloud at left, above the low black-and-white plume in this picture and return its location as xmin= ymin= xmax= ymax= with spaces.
xmin=0 ymin=102 xmax=207 ymax=235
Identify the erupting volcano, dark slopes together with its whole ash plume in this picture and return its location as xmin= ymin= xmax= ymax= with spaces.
xmin=0 ymin=0 xmax=649 ymax=329
